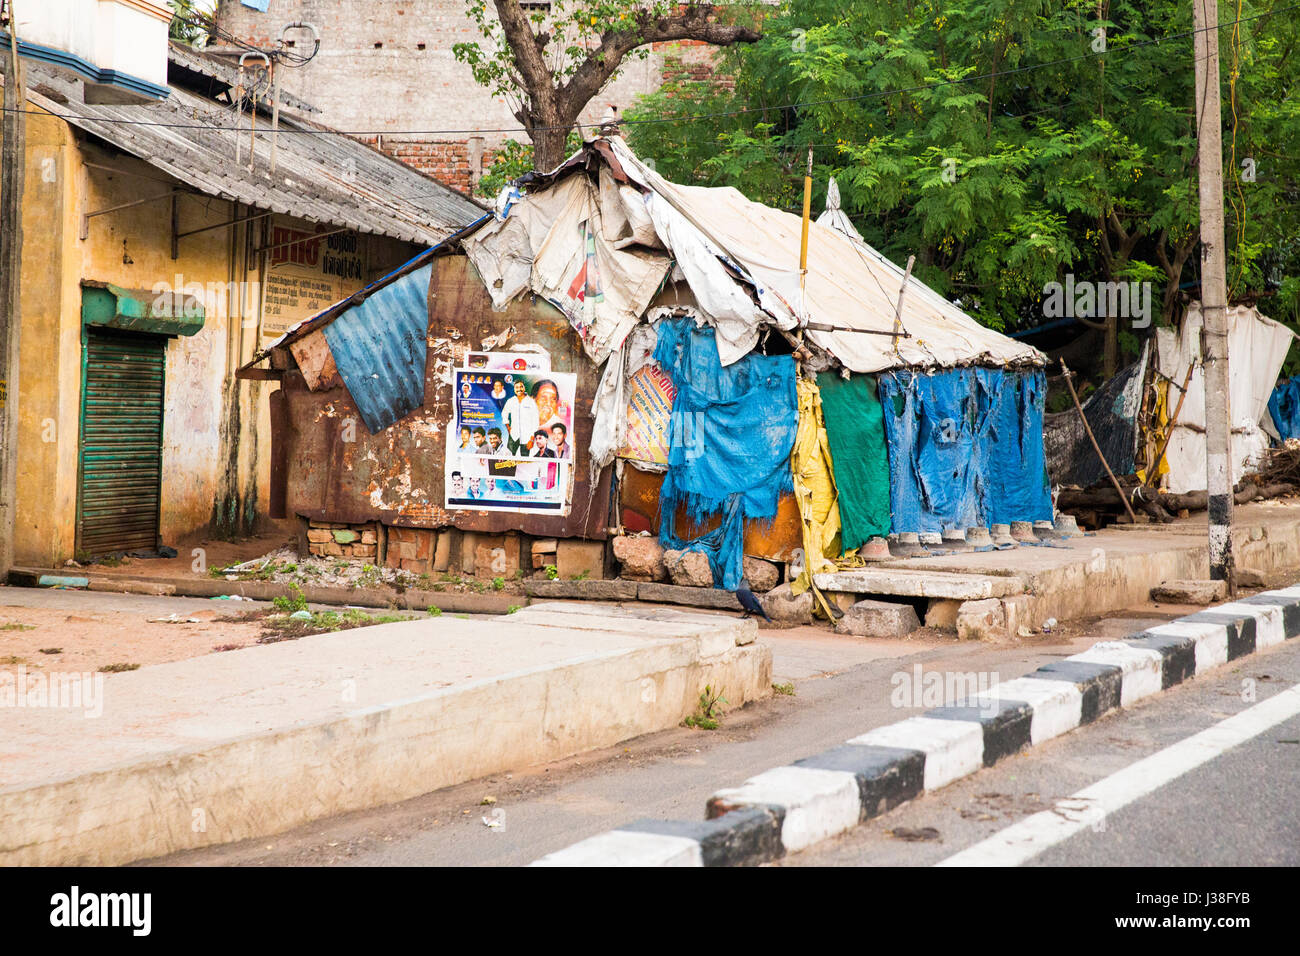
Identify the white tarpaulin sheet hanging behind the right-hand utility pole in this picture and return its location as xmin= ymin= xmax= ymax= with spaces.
xmin=1156 ymin=302 xmax=1295 ymax=494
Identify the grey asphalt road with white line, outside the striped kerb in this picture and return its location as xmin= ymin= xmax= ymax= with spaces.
xmin=777 ymin=641 xmax=1300 ymax=866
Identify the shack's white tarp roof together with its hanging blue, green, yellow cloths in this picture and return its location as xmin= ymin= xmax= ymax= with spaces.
xmin=462 ymin=137 xmax=1052 ymax=587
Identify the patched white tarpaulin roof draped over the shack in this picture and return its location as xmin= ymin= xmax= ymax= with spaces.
xmin=463 ymin=137 xmax=1045 ymax=372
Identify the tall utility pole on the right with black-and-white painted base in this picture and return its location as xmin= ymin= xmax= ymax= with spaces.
xmin=1192 ymin=0 xmax=1235 ymax=591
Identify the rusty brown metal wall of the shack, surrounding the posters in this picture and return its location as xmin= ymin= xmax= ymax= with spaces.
xmin=274 ymin=254 xmax=611 ymax=540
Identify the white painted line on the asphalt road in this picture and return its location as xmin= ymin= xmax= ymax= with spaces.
xmin=936 ymin=684 xmax=1300 ymax=866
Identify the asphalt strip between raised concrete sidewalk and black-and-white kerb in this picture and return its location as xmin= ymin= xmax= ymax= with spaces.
xmin=142 ymin=609 xmax=1216 ymax=866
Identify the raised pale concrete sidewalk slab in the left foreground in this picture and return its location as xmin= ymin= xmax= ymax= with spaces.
xmin=0 ymin=604 xmax=772 ymax=866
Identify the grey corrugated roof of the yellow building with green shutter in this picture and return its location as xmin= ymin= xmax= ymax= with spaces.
xmin=27 ymin=62 xmax=484 ymax=246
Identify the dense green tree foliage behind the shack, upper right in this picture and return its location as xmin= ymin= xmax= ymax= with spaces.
xmin=625 ymin=0 xmax=1300 ymax=343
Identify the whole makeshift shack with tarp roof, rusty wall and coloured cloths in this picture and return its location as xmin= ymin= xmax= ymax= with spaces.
xmin=250 ymin=135 xmax=1053 ymax=598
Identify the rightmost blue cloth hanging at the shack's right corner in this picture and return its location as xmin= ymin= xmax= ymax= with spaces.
xmin=975 ymin=368 xmax=1052 ymax=525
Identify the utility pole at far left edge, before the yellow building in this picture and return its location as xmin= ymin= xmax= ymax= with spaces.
xmin=0 ymin=0 xmax=27 ymax=584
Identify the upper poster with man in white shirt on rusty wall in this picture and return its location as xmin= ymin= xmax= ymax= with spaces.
xmin=457 ymin=368 xmax=577 ymax=463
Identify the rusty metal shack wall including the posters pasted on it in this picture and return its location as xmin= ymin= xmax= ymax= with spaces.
xmin=276 ymin=254 xmax=612 ymax=540
